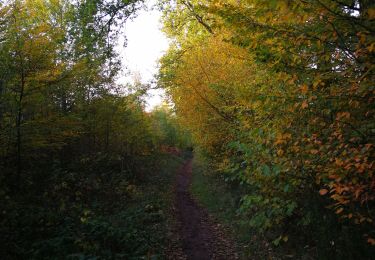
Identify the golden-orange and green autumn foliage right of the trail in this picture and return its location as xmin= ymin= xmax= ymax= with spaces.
xmin=159 ymin=0 xmax=375 ymax=253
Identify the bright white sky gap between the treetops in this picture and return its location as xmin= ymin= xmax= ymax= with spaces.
xmin=116 ymin=0 xmax=169 ymax=111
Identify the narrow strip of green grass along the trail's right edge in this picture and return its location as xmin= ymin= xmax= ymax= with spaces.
xmin=191 ymin=157 xmax=277 ymax=259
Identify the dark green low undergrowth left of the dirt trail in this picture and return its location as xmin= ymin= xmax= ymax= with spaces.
xmin=0 ymin=154 xmax=183 ymax=259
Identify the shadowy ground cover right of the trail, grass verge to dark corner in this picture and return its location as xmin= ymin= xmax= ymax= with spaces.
xmin=191 ymin=158 xmax=373 ymax=259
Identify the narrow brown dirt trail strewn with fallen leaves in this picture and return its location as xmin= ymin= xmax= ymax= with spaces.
xmin=175 ymin=160 xmax=238 ymax=260
